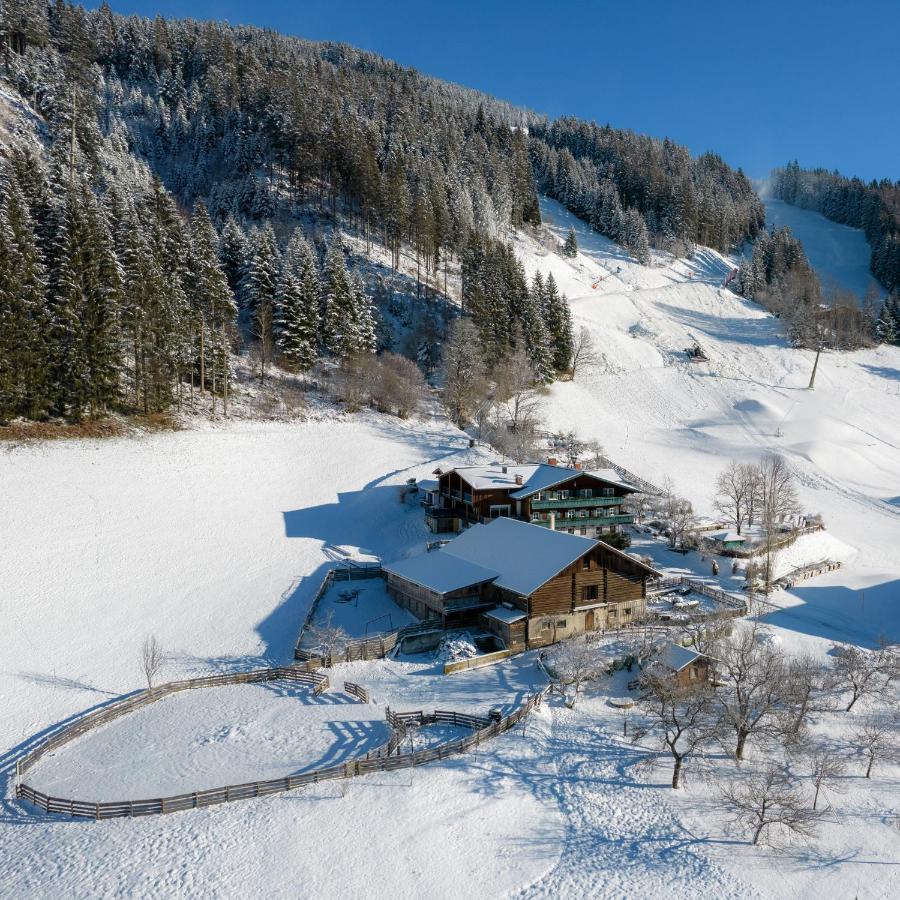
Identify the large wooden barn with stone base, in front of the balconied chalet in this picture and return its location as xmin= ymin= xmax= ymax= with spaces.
xmin=382 ymin=516 xmax=659 ymax=649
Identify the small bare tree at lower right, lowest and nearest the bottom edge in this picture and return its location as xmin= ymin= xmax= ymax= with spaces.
xmin=720 ymin=763 xmax=822 ymax=848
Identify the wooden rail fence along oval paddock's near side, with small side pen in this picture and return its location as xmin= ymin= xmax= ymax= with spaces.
xmin=16 ymin=684 xmax=548 ymax=819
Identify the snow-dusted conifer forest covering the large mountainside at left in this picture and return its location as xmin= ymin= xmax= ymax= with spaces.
xmin=0 ymin=0 xmax=788 ymax=421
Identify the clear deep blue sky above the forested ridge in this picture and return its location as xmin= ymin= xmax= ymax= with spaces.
xmin=87 ymin=0 xmax=900 ymax=179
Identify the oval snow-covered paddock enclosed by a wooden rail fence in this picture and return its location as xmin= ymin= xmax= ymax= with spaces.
xmin=28 ymin=681 xmax=390 ymax=802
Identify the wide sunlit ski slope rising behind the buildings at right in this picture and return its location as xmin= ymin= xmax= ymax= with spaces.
xmin=516 ymin=198 xmax=900 ymax=642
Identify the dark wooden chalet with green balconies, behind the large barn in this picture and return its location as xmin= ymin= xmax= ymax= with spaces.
xmin=426 ymin=458 xmax=638 ymax=537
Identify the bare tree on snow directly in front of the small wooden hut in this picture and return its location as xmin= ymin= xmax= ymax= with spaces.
xmin=639 ymin=668 xmax=718 ymax=789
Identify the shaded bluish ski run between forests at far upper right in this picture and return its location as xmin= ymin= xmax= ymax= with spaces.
xmin=763 ymin=193 xmax=884 ymax=298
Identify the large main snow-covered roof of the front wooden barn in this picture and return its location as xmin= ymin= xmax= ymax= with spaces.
xmin=439 ymin=518 xmax=598 ymax=597
